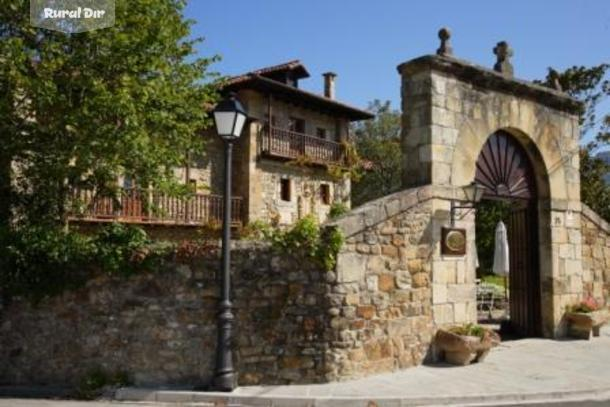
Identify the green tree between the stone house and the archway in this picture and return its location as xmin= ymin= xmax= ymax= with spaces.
xmin=352 ymin=100 xmax=402 ymax=206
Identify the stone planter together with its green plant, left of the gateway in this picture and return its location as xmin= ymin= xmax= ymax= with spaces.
xmin=435 ymin=323 xmax=500 ymax=366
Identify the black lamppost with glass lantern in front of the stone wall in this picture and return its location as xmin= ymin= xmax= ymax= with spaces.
xmin=212 ymin=94 xmax=247 ymax=391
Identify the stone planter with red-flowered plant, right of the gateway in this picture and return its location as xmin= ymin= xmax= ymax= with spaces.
xmin=565 ymin=297 xmax=610 ymax=339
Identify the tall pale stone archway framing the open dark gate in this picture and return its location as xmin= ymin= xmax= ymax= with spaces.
xmin=398 ymin=56 xmax=584 ymax=337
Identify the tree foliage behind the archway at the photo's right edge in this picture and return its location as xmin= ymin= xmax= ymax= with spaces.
xmin=539 ymin=64 xmax=610 ymax=220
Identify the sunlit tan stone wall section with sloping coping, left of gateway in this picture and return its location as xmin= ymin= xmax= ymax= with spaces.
xmin=327 ymin=186 xmax=466 ymax=380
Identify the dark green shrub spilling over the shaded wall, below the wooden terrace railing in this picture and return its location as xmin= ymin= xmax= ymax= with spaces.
xmin=0 ymin=223 xmax=174 ymax=303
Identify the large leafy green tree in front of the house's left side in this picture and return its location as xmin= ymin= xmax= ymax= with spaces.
xmin=0 ymin=0 xmax=216 ymax=228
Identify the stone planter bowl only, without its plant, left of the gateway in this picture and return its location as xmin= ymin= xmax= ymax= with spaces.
xmin=435 ymin=329 xmax=500 ymax=366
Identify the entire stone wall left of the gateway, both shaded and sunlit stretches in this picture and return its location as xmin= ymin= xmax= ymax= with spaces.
xmin=0 ymin=186 xmax=457 ymax=386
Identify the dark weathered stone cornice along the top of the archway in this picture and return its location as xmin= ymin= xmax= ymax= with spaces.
xmin=397 ymin=55 xmax=582 ymax=114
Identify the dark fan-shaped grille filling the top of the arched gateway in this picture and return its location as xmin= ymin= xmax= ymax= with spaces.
xmin=475 ymin=131 xmax=536 ymax=199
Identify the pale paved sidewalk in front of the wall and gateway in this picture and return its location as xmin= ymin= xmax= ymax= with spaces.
xmin=116 ymin=328 xmax=610 ymax=407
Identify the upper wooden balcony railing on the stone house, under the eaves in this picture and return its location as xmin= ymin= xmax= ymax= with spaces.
xmin=261 ymin=127 xmax=345 ymax=165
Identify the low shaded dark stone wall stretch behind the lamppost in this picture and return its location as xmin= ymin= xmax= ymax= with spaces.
xmin=0 ymin=243 xmax=328 ymax=385
